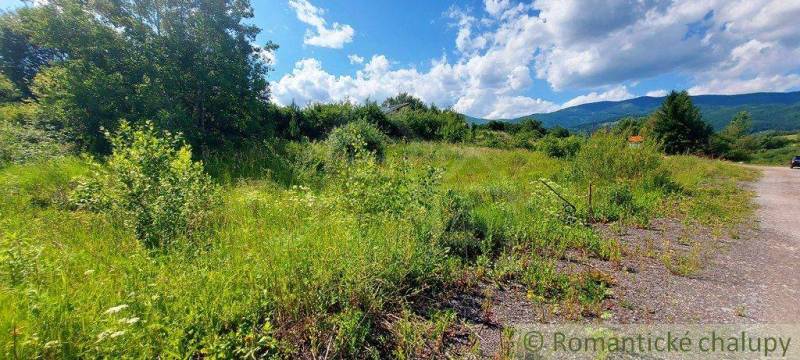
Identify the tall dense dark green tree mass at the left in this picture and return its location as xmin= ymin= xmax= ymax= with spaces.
xmin=6 ymin=0 xmax=275 ymax=151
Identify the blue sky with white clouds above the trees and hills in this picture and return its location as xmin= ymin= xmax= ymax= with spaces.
xmin=0 ymin=0 xmax=800 ymax=119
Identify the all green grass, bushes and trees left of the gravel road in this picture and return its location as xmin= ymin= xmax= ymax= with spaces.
xmin=0 ymin=0 xmax=756 ymax=358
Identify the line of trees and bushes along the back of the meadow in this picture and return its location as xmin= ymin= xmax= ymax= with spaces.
xmin=0 ymin=0 xmax=780 ymax=165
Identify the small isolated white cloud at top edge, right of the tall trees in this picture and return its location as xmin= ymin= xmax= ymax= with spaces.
xmin=289 ymin=0 xmax=355 ymax=49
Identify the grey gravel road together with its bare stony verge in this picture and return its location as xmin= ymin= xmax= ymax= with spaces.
xmin=451 ymin=167 xmax=800 ymax=358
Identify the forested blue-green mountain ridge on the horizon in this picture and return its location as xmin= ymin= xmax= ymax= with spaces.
xmin=468 ymin=91 xmax=800 ymax=131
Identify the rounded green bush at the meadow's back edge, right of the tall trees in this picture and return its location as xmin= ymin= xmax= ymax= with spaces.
xmin=327 ymin=120 xmax=388 ymax=161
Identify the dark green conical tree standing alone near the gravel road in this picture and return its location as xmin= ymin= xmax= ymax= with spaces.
xmin=650 ymin=90 xmax=713 ymax=154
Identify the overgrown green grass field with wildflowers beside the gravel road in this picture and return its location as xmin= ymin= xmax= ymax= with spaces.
xmin=0 ymin=135 xmax=756 ymax=358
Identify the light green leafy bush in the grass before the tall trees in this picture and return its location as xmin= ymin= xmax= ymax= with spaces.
xmin=72 ymin=121 xmax=217 ymax=248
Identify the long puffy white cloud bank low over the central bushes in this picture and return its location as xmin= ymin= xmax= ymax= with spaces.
xmin=272 ymin=55 xmax=558 ymax=118
